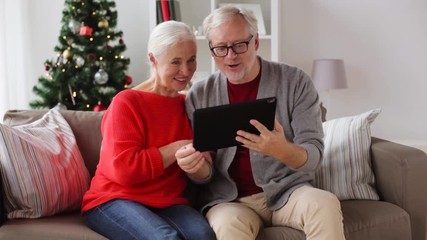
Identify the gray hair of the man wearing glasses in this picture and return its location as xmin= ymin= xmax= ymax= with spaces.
xmin=203 ymin=4 xmax=258 ymax=41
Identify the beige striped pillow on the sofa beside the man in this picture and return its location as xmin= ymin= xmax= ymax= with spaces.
xmin=314 ymin=109 xmax=381 ymax=200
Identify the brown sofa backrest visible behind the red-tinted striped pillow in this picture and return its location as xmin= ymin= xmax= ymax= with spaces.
xmin=3 ymin=110 xmax=104 ymax=176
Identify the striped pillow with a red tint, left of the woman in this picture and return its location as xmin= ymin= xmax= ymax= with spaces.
xmin=0 ymin=109 xmax=90 ymax=219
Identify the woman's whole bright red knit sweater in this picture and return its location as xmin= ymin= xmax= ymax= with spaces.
xmin=82 ymin=90 xmax=192 ymax=212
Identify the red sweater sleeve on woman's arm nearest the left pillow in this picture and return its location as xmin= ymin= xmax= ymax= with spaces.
xmin=98 ymin=91 xmax=164 ymax=185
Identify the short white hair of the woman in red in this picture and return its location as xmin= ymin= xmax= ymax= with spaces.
xmin=147 ymin=21 xmax=196 ymax=57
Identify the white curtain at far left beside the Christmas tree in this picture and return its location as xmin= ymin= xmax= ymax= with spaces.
xmin=0 ymin=0 xmax=34 ymax=121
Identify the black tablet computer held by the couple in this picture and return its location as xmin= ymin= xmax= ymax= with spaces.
xmin=193 ymin=97 xmax=276 ymax=151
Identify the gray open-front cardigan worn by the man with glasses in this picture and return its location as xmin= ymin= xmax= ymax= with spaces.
xmin=186 ymin=58 xmax=323 ymax=210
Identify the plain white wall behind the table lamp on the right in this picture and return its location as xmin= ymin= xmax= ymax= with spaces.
xmin=281 ymin=0 xmax=427 ymax=151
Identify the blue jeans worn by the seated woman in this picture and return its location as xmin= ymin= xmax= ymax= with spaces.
xmin=84 ymin=199 xmax=215 ymax=240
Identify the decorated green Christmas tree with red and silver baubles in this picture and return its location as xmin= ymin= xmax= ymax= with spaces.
xmin=30 ymin=0 xmax=132 ymax=111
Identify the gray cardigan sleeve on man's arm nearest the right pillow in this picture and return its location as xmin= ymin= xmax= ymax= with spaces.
xmin=258 ymin=60 xmax=324 ymax=172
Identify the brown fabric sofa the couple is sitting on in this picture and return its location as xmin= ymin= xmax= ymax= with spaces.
xmin=0 ymin=110 xmax=427 ymax=240
